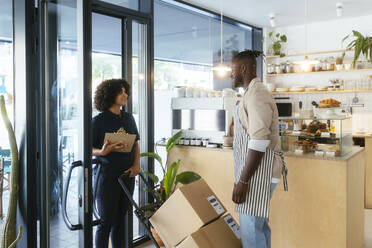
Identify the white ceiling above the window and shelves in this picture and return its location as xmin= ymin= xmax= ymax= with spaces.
xmin=183 ymin=0 xmax=372 ymax=27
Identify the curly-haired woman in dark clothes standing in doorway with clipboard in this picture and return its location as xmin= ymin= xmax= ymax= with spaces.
xmin=92 ymin=79 xmax=140 ymax=248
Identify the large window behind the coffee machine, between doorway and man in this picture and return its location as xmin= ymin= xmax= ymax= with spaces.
xmin=154 ymin=0 xmax=254 ymax=174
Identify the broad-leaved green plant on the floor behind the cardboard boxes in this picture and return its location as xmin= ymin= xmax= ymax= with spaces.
xmin=141 ymin=131 xmax=200 ymax=246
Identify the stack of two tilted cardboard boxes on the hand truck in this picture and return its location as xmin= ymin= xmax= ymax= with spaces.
xmin=150 ymin=179 xmax=240 ymax=248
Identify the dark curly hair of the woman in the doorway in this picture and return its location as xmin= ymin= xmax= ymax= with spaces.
xmin=94 ymin=79 xmax=130 ymax=112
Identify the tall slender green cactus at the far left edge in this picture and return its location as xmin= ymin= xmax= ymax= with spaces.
xmin=0 ymin=95 xmax=22 ymax=248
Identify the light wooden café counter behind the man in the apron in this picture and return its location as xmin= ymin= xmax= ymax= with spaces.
xmin=169 ymin=146 xmax=364 ymax=248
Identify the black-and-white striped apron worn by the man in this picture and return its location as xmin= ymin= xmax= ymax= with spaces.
xmin=234 ymin=105 xmax=275 ymax=218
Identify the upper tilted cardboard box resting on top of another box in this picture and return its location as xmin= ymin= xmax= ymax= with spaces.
xmin=150 ymin=179 xmax=225 ymax=247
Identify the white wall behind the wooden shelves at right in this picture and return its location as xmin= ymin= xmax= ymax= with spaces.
xmin=264 ymin=15 xmax=372 ymax=131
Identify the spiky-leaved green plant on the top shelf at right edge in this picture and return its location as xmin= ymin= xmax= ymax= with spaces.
xmin=342 ymin=30 xmax=372 ymax=67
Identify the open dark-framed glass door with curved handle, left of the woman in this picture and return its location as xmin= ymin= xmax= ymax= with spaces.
xmin=39 ymin=0 xmax=94 ymax=248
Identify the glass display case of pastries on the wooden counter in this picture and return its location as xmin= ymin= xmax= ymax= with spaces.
xmin=279 ymin=117 xmax=353 ymax=157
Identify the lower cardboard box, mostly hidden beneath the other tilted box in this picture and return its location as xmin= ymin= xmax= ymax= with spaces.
xmin=177 ymin=215 xmax=242 ymax=248
